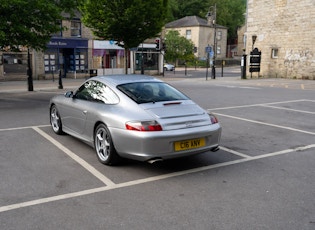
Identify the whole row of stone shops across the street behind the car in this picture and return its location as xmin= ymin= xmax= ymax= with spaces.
xmin=0 ymin=14 xmax=156 ymax=81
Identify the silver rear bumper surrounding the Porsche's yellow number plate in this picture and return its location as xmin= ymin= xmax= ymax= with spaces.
xmin=110 ymin=124 xmax=222 ymax=161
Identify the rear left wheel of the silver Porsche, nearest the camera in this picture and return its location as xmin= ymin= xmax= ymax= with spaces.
xmin=94 ymin=124 xmax=120 ymax=165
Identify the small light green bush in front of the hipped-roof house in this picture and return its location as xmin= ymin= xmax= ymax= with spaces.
xmin=165 ymin=30 xmax=194 ymax=63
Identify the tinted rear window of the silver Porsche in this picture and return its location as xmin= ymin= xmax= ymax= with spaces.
xmin=117 ymin=82 xmax=189 ymax=104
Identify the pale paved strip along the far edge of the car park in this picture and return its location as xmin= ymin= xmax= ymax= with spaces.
xmin=0 ymin=66 xmax=315 ymax=93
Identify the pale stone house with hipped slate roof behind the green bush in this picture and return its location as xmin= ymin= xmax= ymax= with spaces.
xmin=165 ymin=16 xmax=227 ymax=61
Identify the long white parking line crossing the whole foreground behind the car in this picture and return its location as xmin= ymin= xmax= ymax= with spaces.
xmin=0 ymin=144 xmax=315 ymax=213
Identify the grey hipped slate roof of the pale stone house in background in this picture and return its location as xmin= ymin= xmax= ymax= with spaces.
xmin=165 ymin=16 xmax=226 ymax=28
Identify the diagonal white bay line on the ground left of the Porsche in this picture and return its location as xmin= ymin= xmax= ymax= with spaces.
xmin=32 ymin=127 xmax=115 ymax=186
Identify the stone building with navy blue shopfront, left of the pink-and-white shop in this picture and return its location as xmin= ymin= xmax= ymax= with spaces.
xmin=0 ymin=14 xmax=97 ymax=80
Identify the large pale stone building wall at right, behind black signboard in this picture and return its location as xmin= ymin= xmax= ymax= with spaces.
xmin=245 ymin=0 xmax=315 ymax=80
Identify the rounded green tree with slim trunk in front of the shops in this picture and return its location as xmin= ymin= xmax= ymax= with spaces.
xmin=80 ymin=0 xmax=168 ymax=73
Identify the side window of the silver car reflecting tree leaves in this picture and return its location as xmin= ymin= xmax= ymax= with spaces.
xmin=75 ymin=80 xmax=119 ymax=104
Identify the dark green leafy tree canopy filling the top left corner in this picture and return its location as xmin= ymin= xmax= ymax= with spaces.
xmin=0 ymin=0 xmax=76 ymax=50
